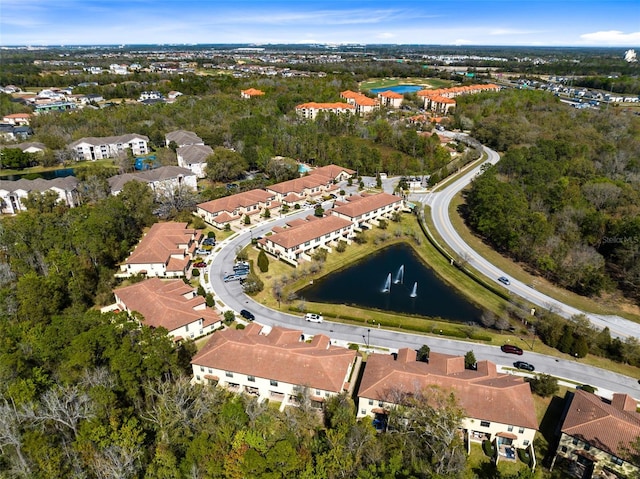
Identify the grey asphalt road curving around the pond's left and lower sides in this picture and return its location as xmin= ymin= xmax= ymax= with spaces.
xmin=205 ymin=185 xmax=640 ymax=398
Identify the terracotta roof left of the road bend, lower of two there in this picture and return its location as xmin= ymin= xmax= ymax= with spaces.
xmin=114 ymin=278 xmax=221 ymax=331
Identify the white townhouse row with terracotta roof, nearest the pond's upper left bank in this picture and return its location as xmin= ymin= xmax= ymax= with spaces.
xmin=258 ymin=215 xmax=354 ymax=266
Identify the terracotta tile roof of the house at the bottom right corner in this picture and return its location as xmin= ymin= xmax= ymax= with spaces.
xmin=562 ymin=389 xmax=640 ymax=457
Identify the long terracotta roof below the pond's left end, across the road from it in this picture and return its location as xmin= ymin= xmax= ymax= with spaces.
xmin=191 ymin=323 xmax=356 ymax=393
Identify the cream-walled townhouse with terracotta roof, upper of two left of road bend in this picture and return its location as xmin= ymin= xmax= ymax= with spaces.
xmin=116 ymin=222 xmax=203 ymax=278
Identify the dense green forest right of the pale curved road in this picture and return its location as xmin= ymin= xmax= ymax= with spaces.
xmin=457 ymin=91 xmax=640 ymax=304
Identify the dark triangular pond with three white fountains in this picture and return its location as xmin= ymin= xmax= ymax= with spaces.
xmin=298 ymin=243 xmax=481 ymax=323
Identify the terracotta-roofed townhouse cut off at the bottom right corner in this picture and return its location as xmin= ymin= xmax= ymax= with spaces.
xmin=552 ymin=389 xmax=640 ymax=479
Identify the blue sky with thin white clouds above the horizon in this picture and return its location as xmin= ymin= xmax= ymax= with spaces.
xmin=0 ymin=0 xmax=640 ymax=48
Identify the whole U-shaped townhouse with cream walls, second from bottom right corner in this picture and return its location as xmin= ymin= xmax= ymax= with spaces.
xmin=357 ymin=348 xmax=538 ymax=458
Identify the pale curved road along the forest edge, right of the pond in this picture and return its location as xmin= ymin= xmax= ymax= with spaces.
xmin=419 ymin=140 xmax=640 ymax=338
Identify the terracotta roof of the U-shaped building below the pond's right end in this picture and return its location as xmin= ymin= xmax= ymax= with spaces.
xmin=358 ymin=348 xmax=538 ymax=429
